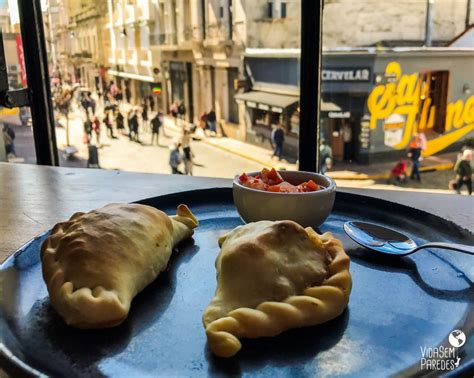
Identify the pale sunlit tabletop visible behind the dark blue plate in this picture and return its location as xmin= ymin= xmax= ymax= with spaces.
xmin=0 ymin=163 xmax=474 ymax=262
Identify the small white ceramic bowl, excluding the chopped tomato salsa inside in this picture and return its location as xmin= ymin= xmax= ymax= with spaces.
xmin=233 ymin=171 xmax=336 ymax=227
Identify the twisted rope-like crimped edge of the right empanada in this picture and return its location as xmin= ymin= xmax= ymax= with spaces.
xmin=206 ymin=227 xmax=352 ymax=357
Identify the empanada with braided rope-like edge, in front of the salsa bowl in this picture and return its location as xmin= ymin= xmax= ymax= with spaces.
xmin=203 ymin=221 xmax=352 ymax=357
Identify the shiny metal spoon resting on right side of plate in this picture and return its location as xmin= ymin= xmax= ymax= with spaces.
xmin=344 ymin=222 xmax=474 ymax=256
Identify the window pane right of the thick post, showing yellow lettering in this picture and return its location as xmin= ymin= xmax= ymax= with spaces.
xmin=321 ymin=0 xmax=474 ymax=192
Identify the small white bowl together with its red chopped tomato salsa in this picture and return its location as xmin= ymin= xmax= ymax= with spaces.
xmin=233 ymin=169 xmax=336 ymax=227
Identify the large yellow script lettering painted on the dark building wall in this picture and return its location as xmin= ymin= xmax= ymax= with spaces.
xmin=367 ymin=62 xmax=474 ymax=156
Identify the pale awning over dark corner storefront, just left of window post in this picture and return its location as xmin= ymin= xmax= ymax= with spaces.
xmin=235 ymin=91 xmax=299 ymax=113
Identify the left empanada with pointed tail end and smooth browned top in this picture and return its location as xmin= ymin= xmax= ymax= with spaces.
xmin=41 ymin=204 xmax=198 ymax=328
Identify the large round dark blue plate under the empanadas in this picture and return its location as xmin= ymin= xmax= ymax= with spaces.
xmin=0 ymin=189 xmax=474 ymax=377
